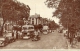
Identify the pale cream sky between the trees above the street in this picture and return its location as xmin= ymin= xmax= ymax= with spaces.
xmin=18 ymin=0 xmax=59 ymax=23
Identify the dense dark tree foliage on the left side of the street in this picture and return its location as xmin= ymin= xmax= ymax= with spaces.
xmin=0 ymin=0 xmax=30 ymax=35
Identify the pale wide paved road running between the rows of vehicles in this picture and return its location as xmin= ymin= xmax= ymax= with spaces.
xmin=0 ymin=31 xmax=68 ymax=49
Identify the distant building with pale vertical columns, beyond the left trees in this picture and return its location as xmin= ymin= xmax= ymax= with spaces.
xmin=27 ymin=14 xmax=49 ymax=25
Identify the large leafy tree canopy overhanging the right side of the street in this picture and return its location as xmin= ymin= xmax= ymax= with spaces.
xmin=46 ymin=0 xmax=80 ymax=28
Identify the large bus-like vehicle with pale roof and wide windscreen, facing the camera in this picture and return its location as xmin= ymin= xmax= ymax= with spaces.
xmin=22 ymin=25 xmax=34 ymax=39
